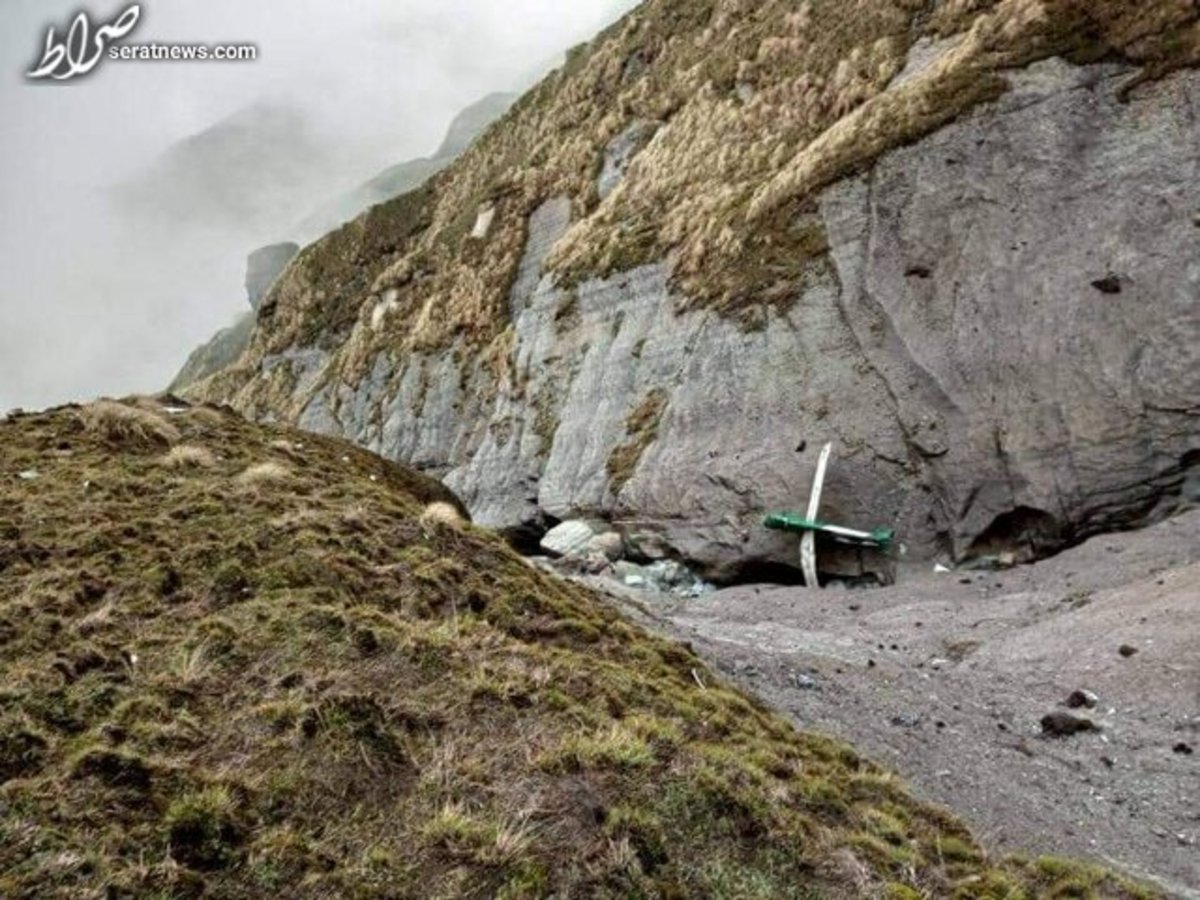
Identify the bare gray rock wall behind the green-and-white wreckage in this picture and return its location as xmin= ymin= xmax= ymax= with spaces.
xmin=238 ymin=60 xmax=1200 ymax=578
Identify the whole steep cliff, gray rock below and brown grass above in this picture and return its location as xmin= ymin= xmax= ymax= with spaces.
xmin=189 ymin=0 xmax=1200 ymax=578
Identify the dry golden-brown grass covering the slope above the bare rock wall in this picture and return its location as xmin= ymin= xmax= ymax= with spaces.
xmin=198 ymin=0 xmax=1200 ymax=413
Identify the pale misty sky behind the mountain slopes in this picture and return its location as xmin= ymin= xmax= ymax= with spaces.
xmin=0 ymin=0 xmax=635 ymax=412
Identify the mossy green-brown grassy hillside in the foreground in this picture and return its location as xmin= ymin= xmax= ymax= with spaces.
xmin=0 ymin=400 xmax=1161 ymax=899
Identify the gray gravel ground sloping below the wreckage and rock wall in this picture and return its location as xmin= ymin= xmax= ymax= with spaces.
xmin=576 ymin=511 xmax=1200 ymax=898
